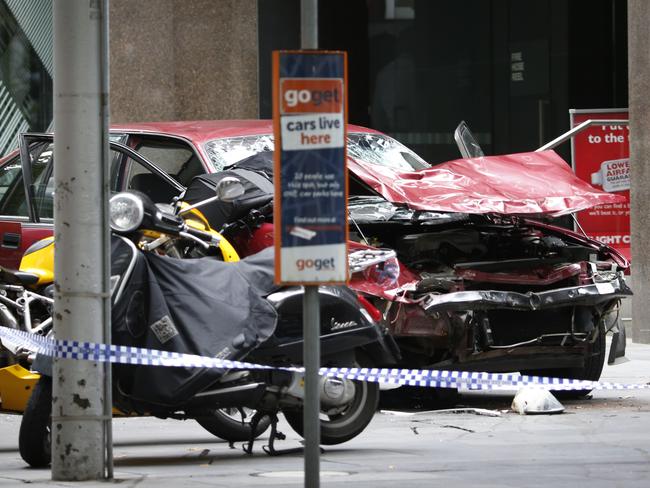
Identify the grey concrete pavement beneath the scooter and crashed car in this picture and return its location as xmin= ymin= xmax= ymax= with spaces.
xmin=0 ymin=343 xmax=650 ymax=488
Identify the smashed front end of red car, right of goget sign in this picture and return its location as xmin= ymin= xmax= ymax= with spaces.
xmin=249 ymin=124 xmax=631 ymax=390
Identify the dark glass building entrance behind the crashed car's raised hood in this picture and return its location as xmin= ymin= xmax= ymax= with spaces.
xmin=258 ymin=0 xmax=627 ymax=163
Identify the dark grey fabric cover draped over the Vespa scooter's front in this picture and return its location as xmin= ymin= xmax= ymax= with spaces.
xmin=112 ymin=238 xmax=277 ymax=407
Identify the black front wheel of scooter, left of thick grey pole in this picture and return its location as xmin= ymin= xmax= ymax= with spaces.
xmin=18 ymin=376 xmax=52 ymax=468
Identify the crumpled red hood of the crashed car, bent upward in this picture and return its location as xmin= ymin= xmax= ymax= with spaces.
xmin=348 ymin=151 xmax=625 ymax=216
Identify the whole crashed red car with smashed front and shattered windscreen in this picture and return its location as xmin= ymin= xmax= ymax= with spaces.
xmin=0 ymin=121 xmax=631 ymax=386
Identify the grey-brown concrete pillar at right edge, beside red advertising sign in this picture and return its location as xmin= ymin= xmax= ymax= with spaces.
xmin=627 ymin=0 xmax=650 ymax=344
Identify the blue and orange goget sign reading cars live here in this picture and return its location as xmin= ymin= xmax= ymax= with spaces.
xmin=273 ymin=51 xmax=348 ymax=284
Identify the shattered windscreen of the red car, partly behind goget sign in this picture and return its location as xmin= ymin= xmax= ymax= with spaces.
xmin=204 ymin=133 xmax=430 ymax=171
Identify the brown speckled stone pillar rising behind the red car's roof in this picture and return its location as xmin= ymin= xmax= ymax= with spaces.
xmin=110 ymin=0 xmax=258 ymax=122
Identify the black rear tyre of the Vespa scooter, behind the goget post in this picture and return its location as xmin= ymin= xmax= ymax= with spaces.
xmin=282 ymin=381 xmax=379 ymax=445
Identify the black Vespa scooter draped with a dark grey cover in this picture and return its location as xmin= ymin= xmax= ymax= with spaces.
xmin=19 ymin=185 xmax=398 ymax=466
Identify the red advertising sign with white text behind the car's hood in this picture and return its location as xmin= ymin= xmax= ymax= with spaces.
xmin=570 ymin=109 xmax=630 ymax=259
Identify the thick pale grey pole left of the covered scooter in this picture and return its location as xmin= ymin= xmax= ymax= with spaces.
xmin=52 ymin=0 xmax=112 ymax=481
